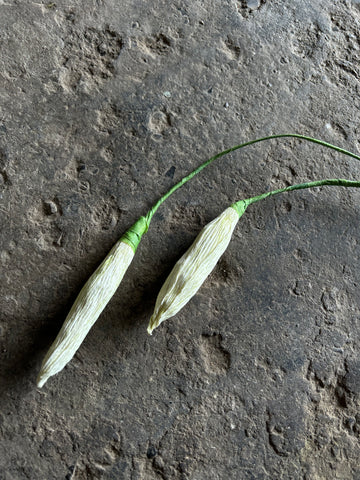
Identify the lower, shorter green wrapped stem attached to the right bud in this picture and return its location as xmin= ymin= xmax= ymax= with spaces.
xmin=231 ymin=178 xmax=360 ymax=216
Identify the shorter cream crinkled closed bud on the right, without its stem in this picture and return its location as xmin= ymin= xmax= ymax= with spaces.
xmin=147 ymin=202 xmax=247 ymax=335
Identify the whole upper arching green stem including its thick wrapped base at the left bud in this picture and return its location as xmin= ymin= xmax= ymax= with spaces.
xmin=119 ymin=133 xmax=360 ymax=251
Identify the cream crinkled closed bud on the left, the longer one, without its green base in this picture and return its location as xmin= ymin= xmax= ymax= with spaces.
xmin=37 ymin=241 xmax=134 ymax=387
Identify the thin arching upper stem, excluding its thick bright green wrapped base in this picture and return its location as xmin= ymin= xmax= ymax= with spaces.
xmin=145 ymin=133 xmax=360 ymax=225
